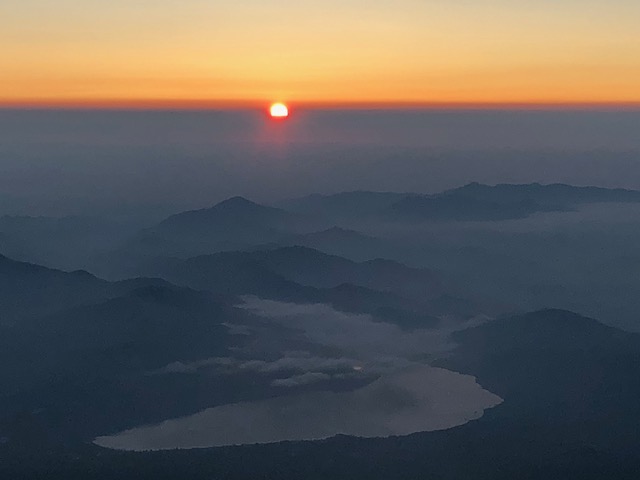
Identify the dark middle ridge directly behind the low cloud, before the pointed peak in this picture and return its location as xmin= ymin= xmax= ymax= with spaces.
xmin=131 ymin=246 xmax=464 ymax=327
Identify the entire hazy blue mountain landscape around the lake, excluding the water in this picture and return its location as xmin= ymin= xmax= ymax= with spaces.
xmin=0 ymin=183 xmax=640 ymax=480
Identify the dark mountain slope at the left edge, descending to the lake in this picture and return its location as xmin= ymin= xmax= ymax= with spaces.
xmin=0 ymin=257 xmax=258 ymax=442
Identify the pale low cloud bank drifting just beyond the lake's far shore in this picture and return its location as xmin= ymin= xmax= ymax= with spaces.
xmin=152 ymin=296 xmax=476 ymax=378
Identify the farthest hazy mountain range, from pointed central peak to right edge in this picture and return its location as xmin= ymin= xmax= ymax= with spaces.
xmin=100 ymin=183 xmax=640 ymax=274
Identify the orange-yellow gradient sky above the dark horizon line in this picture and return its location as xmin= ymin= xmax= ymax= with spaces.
xmin=0 ymin=0 xmax=640 ymax=105
